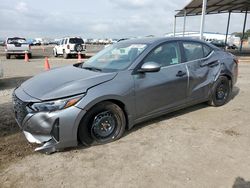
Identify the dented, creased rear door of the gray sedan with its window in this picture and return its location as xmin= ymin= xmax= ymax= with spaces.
xmin=183 ymin=42 xmax=219 ymax=101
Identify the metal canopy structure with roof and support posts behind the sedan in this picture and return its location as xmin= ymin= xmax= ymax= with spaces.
xmin=174 ymin=0 xmax=250 ymax=50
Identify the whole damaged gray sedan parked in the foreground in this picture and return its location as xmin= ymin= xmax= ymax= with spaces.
xmin=13 ymin=38 xmax=238 ymax=153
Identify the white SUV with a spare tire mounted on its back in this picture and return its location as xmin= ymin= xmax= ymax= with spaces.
xmin=53 ymin=37 xmax=86 ymax=59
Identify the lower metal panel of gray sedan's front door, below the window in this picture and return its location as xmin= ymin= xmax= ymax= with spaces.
xmin=134 ymin=64 xmax=187 ymax=118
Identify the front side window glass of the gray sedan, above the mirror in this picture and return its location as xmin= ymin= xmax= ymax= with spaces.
xmin=144 ymin=42 xmax=181 ymax=67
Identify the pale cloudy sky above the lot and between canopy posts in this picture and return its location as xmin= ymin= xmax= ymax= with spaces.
xmin=0 ymin=0 xmax=250 ymax=38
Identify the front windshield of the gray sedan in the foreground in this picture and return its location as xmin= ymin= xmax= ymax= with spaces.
xmin=82 ymin=43 xmax=147 ymax=72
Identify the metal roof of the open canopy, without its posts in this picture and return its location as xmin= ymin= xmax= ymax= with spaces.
xmin=175 ymin=0 xmax=250 ymax=17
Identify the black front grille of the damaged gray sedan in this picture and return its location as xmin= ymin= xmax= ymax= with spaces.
xmin=13 ymin=94 xmax=28 ymax=126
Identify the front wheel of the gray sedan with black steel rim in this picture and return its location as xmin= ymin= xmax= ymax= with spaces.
xmin=78 ymin=102 xmax=126 ymax=146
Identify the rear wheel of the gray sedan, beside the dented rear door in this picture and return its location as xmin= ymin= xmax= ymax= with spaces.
xmin=208 ymin=76 xmax=232 ymax=106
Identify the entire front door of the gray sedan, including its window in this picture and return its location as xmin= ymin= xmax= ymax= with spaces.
xmin=134 ymin=42 xmax=188 ymax=118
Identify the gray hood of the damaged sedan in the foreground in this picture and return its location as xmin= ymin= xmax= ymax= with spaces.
xmin=20 ymin=65 xmax=117 ymax=101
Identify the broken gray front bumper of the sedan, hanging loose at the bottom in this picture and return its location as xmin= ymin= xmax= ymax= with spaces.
xmin=13 ymin=89 xmax=83 ymax=154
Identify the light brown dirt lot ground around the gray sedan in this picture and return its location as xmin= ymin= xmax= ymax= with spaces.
xmin=0 ymin=47 xmax=250 ymax=188
